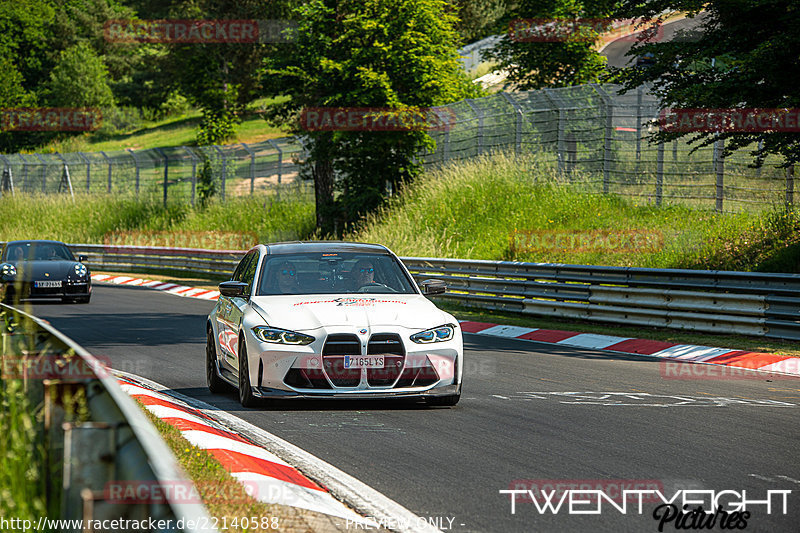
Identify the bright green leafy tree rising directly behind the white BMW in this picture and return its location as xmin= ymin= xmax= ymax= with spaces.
xmin=264 ymin=0 xmax=478 ymax=234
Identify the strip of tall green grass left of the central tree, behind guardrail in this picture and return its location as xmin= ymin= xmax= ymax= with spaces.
xmin=0 ymin=194 xmax=315 ymax=248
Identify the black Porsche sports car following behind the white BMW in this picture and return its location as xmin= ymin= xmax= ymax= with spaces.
xmin=0 ymin=241 xmax=92 ymax=303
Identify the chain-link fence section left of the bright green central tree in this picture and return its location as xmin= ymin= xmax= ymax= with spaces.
xmin=0 ymin=137 xmax=313 ymax=204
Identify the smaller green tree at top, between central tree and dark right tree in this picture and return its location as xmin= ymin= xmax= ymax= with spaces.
xmin=487 ymin=0 xmax=616 ymax=90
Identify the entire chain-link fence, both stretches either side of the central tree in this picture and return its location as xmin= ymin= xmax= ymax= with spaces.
xmin=0 ymin=84 xmax=794 ymax=211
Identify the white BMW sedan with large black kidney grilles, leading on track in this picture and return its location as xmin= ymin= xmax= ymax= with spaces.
xmin=206 ymin=241 xmax=464 ymax=407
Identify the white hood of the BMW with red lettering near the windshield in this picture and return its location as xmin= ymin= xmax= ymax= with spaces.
xmin=251 ymin=294 xmax=452 ymax=331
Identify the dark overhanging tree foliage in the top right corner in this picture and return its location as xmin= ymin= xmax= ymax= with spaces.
xmin=615 ymin=0 xmax=800 ymax=165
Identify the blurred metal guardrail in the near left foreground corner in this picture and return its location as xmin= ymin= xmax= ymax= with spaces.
xmin=0 ymin=304 xmax=216 ymax=532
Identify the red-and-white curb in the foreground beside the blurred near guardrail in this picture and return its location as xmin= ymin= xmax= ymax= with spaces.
xmin=119 ymin=379 xmax=376 ymax=526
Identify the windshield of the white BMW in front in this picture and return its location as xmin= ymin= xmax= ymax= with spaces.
xmin=256 ymin=252 xmax=416 ymax=295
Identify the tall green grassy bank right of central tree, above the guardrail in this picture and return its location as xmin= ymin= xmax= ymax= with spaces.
xmin=350 ymin=154 xmax=800 ymax=272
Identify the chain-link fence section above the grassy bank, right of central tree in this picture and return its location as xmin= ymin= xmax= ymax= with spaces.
xmin=424 ymin=84 xmax=794 ymax=211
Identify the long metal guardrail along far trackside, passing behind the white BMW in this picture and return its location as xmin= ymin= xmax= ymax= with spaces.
xmin=54 ymin=244 xmax=800 ymax=340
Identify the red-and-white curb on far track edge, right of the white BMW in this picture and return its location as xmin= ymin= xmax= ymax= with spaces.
xmin=461 ymin=321 xmax=800 ymax=376
